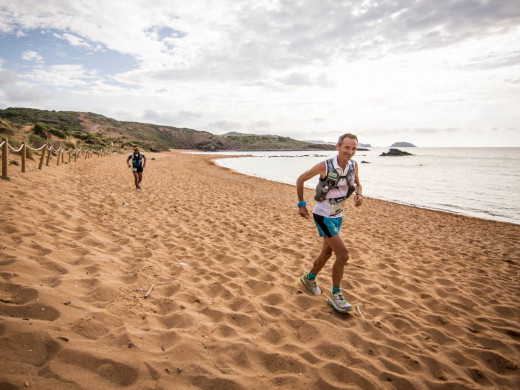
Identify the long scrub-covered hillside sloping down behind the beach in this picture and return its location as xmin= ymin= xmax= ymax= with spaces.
xmin=0 ymin=107 xmax=335 ymax=152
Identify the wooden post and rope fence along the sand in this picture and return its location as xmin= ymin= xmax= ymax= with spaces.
xmin=0 ymin=137 xmax=110 ymax=179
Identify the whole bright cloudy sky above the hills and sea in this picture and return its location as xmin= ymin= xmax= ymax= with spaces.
xmin=0 ymin=0 xmax=520 ymax=146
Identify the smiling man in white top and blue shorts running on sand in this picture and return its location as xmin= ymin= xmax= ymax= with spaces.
xmin=296 ymin=133 xmax=363 ymax=312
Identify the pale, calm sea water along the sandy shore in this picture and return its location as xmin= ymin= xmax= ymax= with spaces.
xmin=208 ymin=148 xmax=520 ymax=224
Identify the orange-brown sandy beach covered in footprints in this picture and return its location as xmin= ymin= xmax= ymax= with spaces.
xmin=0 ymin=151 xmax=520 ymax=390
